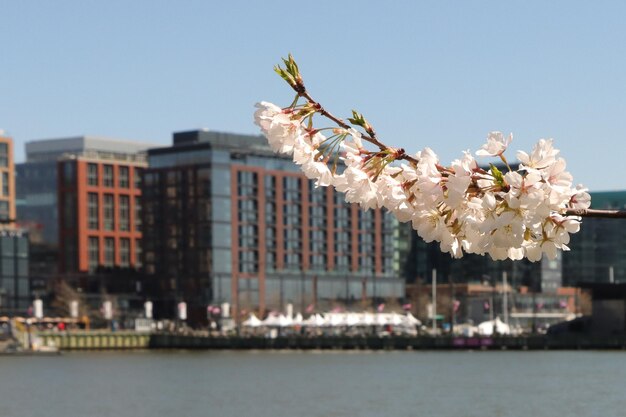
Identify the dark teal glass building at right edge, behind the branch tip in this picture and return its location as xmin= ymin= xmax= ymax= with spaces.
xmin=563 ymin=191 xmax=626 ymax=286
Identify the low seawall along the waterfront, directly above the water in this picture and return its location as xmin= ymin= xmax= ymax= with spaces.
xmin=36 ymin=331 xmax=626 ymax=350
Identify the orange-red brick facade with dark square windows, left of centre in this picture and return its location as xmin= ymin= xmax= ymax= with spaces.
xmin=58 ymin=154 xmax=146 ymax=274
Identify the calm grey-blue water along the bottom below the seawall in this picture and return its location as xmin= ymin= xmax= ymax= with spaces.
xmin=0 ymin=352 xmax=626 ymax=417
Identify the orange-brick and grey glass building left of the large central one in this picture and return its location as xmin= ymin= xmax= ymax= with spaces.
xmin=17 ymin=136 xmax=155 ymax=281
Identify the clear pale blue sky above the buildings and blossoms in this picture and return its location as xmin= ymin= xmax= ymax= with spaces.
xmin=0 ymin=0 xmax=626 ymax=191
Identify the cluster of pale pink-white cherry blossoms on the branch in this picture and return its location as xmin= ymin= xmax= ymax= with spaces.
xmin=254 ymin=57 xmax=591 ymax=261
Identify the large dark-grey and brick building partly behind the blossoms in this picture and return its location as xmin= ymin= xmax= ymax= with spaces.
xmin=142 ymin=130 xmax=404 ymax=320
